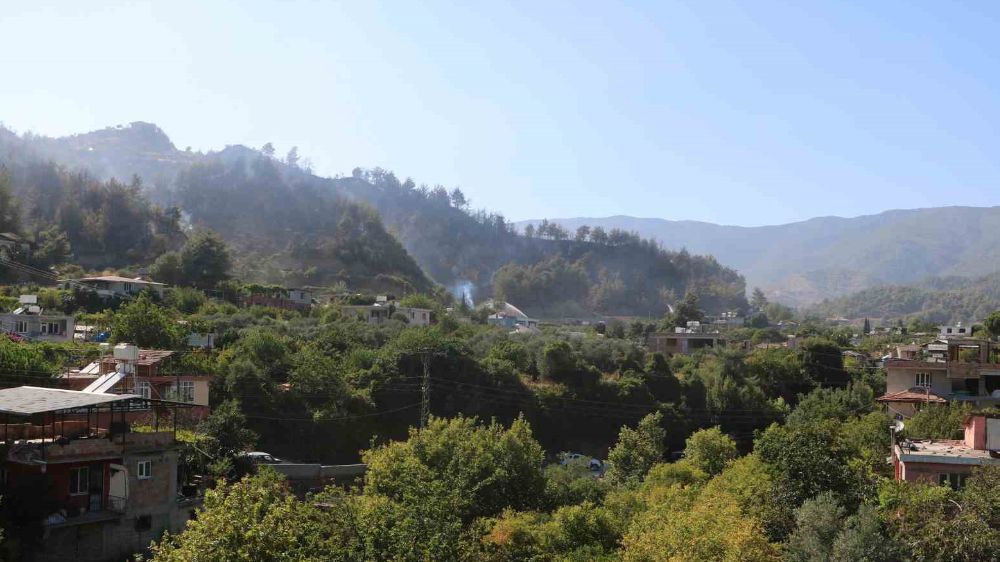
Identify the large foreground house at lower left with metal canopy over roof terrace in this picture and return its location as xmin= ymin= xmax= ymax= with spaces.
xmin=0 ymin=386 xmax=200 ymax=562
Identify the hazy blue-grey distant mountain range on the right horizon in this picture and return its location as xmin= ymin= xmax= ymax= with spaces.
xmin=517 ymin=207 xmax=1000 ymax=306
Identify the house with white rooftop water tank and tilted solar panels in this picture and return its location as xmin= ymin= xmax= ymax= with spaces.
xmin=59 ymin=344 xmax=211 ymax=421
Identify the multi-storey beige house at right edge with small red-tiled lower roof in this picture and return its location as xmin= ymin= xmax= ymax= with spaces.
xmin=877 ymin=327 xmax=1000 ymax=418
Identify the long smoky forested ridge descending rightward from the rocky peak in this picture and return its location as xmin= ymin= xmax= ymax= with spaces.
xmin=0 ymin=123 xmax=746 ymax=316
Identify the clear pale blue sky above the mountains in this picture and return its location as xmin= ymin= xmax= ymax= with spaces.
xmin=0 ymin=0 xmax=1000 ymax=225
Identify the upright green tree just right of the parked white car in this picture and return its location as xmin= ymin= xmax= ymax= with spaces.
xmin=607 ymin=412 xmax=667 ymax=486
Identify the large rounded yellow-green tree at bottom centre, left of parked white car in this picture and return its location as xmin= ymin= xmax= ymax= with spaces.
xmin=362 ymin=417 xmax=545 ymax=522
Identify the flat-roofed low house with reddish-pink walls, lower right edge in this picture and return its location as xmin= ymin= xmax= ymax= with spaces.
xmin=892 ymin=413 xmax=1000 ymax=489
